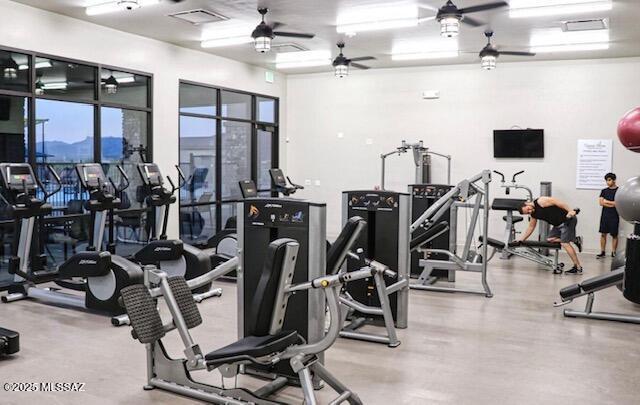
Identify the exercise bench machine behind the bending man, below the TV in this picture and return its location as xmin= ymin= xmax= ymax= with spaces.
xmin=480 ymin=170 xmax=564 ymax=272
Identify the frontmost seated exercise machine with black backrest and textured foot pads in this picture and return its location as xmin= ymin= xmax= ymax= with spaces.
xmin=122 ymin=220 xmax=386 ymax=405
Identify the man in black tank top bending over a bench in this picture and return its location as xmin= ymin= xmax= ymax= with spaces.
xmin=519 ymin=197 xmax=582 ymax=274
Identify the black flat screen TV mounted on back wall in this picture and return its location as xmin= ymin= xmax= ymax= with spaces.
xmin=493 ymin=128 xmax=544 ymax=158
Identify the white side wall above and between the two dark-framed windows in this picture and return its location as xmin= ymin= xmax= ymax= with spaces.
xmin=0 ymin=0 xmax=286 ymax=237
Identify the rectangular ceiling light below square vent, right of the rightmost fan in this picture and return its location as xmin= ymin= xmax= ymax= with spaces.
xmin=529 ymin=28 xmax=609 ymax=53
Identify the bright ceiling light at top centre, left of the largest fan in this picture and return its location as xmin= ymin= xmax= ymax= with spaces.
xmin=336 ymin=6 xmax=419 ymax=34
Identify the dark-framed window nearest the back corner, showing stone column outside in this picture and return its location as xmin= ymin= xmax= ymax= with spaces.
xmin=179 ymin=82 xmax=278 ymax=242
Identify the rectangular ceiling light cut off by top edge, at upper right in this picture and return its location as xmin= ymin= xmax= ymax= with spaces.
xmin=509 ymin=0 xmax=613 ymax=18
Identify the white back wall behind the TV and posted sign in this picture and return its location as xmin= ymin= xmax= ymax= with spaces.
xmin=287 ymin=58 xmax=640 ymax=249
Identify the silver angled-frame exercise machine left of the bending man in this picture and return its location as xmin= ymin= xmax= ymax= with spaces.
xmin=409 ymin=170 xmax=493 ymax=298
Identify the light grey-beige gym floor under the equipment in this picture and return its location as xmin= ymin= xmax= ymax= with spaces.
xmin=0 ymin=254 xmax=640 ymax=405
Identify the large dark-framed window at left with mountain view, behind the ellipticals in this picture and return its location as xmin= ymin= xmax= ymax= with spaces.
xmin=0 ymin=45 xmax=152 ymax=274
